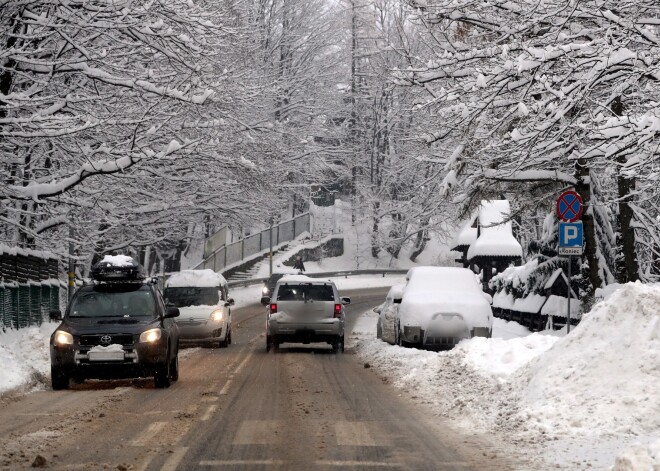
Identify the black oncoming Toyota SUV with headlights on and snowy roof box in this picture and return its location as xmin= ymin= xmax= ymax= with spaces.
xmin=50 ymin=255 xmax=179 ymax=389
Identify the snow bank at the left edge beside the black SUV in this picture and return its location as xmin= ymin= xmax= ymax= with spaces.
xmin=0 ymin=323 xmax=58 ymax=396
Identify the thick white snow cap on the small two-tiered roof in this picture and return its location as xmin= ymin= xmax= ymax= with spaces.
xmin=467 ymin=200 xmax=522 ymax=259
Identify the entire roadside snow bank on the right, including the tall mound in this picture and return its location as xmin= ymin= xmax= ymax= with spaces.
xmin=351 ymin=283 xmax=660 ymax=471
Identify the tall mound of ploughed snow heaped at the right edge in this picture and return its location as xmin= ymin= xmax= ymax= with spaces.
xmin=513 ymin=283 xmax=660 ymax=434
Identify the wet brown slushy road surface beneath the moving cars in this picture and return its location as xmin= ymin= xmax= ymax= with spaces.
xmin=0 ymin=289 xmax=510 ymax=471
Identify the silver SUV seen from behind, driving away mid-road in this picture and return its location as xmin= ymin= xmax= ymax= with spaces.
xmin=261 ymin=275 xmax=351 ymax=353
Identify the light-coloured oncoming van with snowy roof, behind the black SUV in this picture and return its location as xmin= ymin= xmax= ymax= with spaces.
xmin=163 ymin=269 xmax=234 ymax=347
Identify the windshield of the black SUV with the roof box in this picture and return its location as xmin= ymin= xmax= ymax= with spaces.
xmin=69 ymin=283 xmax=156 ymax=317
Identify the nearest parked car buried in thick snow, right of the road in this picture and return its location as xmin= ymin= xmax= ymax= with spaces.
xmin=396 ymin=267 xmax=493 ymax=348
